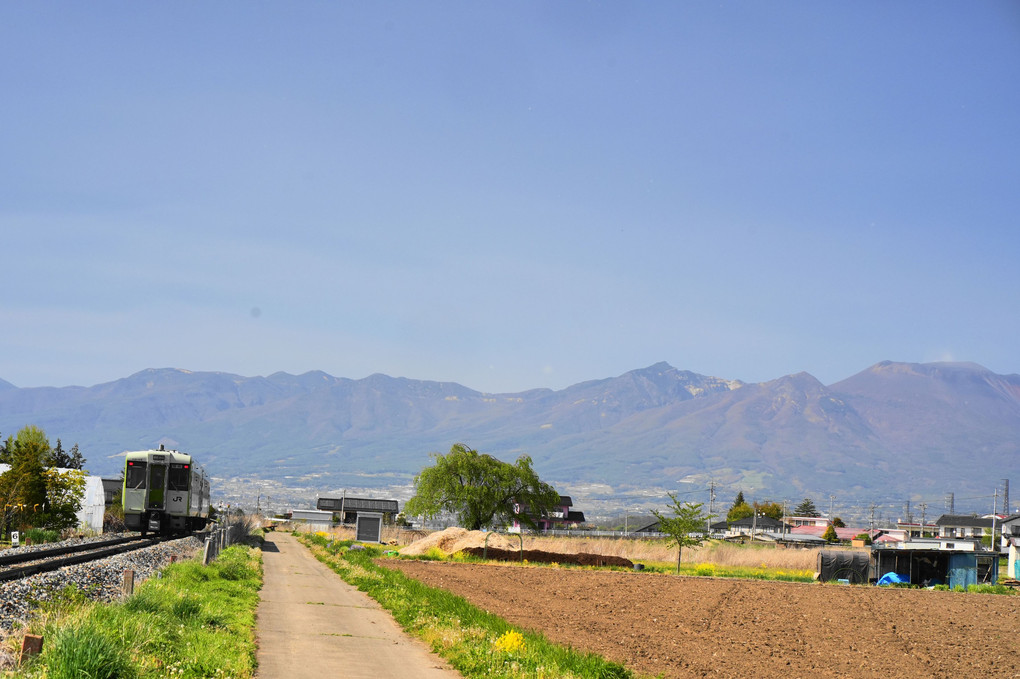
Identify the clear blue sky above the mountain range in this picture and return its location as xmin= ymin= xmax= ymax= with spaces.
xmin=0 ymin=2 xmax=1020 ymax=391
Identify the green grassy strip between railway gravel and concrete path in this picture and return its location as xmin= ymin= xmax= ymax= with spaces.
xmin=7 ymin=545 xmax=262 ymax=679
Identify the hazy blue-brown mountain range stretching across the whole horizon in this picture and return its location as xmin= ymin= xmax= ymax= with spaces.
xmin=0 ymin=362 xmax=1020 ymax=498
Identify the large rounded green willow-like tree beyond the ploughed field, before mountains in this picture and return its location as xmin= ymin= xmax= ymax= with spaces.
xmin=404 ymin=443 xmax=560 ymax=530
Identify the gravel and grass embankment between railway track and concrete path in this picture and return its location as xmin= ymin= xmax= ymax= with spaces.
xmin=0 ymin=538 xmax=262 ymax=679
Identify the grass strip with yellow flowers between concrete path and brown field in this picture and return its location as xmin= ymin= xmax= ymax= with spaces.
xmin=299 ymin=533 xmax=634 ymax=679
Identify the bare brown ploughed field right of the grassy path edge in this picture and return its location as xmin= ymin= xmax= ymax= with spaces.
xmin=379 ymin=560 xmax=1020 ymax=679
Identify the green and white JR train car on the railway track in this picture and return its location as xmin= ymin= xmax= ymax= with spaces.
xmin=122 ymin=446 xmax=209 ymax=536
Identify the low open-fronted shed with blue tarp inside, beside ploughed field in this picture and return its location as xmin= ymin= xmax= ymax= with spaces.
xmin=871 ymin=540 xmax=999 ymax=587
